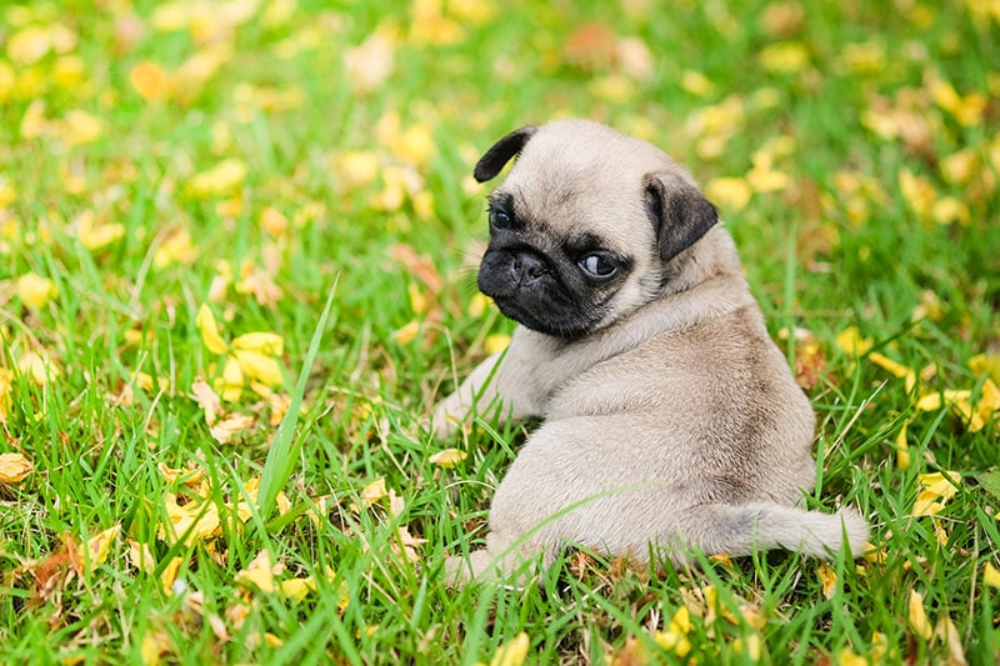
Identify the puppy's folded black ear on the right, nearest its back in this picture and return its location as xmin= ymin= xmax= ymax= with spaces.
xmin=645 ymin=174 xmax=719 ymax=261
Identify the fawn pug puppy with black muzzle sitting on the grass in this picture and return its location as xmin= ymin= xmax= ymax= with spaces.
xmin=433 ymin=120 xmax=869 ymax=582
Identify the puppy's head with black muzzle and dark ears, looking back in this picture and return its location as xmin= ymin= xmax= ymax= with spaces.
xmin=474 ymin=120 xmax=718 ymax=339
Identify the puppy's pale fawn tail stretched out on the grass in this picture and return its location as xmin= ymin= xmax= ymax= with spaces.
xmin=678 ymin=502 xmax=870 ymax=559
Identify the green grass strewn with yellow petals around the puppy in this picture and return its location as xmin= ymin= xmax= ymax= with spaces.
xmin=0 ymin=0 xmax=1000 ymax=666
